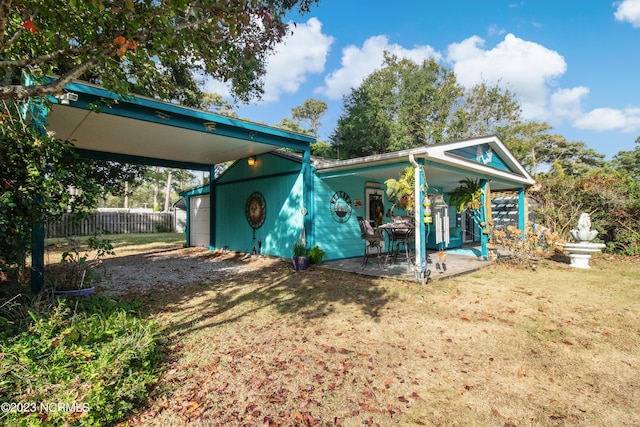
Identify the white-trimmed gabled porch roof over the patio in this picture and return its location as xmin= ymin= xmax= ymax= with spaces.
xmin=314 ymin=136 xmax=535 ymax=192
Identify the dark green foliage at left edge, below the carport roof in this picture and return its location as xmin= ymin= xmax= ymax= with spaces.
xmin=0 ymin=103 xmax=113 ymax=272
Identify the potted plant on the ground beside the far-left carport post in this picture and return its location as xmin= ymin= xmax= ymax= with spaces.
xmin=46 ymin=236 xmax=114 ymax=298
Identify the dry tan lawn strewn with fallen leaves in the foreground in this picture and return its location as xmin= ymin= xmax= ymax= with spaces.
xmin=116 ymin=253 xmax=640 ymax=426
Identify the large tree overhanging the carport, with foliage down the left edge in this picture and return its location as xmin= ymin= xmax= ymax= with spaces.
xmin=0 ymin=0 xmax=318 ymax=290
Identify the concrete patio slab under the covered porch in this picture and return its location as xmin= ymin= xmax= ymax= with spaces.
xmin=322 ymin=246 xmax=492 ymax=282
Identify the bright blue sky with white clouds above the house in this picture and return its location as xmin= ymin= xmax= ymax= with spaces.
xmin=205 ymin=0 xmax=640 ymax=159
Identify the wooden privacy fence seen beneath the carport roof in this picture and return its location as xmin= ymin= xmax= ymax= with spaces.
xmin=45 ymin=212 xmax=174 ymax=237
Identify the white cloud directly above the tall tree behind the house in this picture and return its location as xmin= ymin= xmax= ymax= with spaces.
xmin=314 ymin=36 xmax=440 ymax=99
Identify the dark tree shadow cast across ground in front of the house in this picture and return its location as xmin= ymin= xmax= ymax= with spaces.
xmin=112 ymin=252 xmax=395 ymax=342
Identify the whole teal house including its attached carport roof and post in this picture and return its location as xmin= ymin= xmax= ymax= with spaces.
xmin=32 ymin=81 xmax=534 ymax=288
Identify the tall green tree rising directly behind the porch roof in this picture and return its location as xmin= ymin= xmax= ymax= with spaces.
xmin=331 ymin=54 xmax=463 ymax=158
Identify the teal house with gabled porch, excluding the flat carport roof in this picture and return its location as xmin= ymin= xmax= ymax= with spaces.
xmin=181 ymin=136 xmax=534 ymax=260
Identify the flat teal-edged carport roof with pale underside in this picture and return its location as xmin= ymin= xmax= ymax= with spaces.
xmin=46 ymin=81 xmax=315 ymax=170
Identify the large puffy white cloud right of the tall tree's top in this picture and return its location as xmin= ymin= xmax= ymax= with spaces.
xmin=447 ymin=34 xmax=567 ymax=120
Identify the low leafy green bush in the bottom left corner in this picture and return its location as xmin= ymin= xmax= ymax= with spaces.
xmin=0 ymin=298 xmax=160 ymax=426
